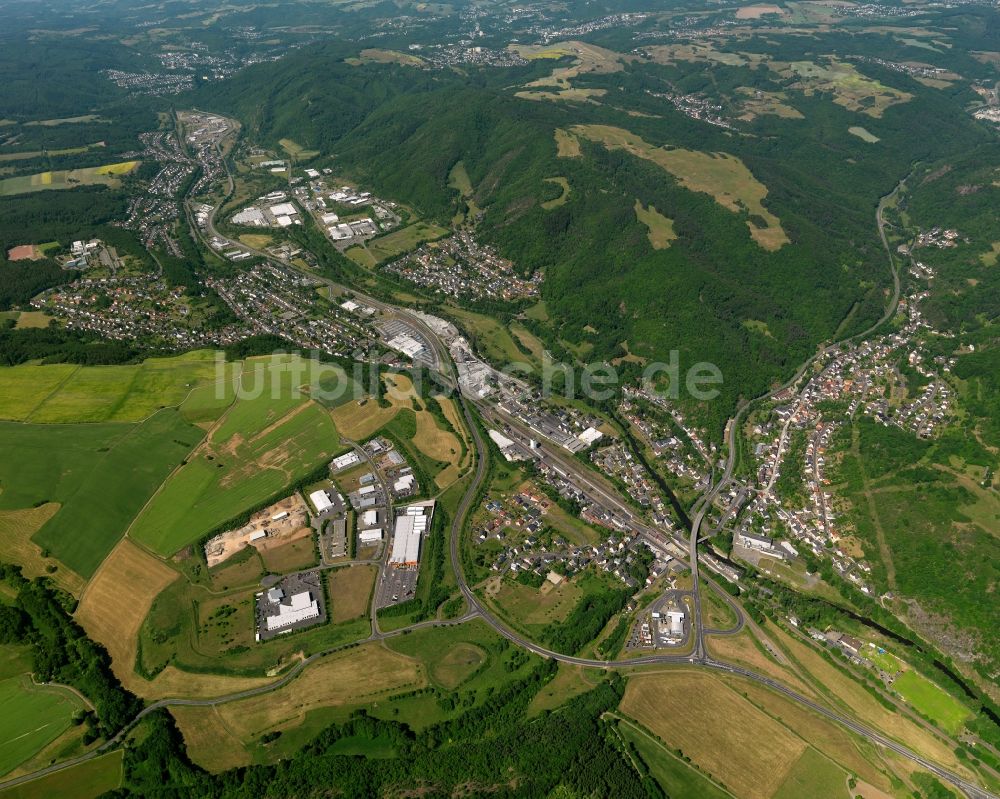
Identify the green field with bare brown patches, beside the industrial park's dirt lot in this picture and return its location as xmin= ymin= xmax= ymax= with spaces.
xmin=130 ymin=382 xmax=339 ymax=556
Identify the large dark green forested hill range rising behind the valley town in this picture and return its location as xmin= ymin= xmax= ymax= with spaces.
xmin=196 ymin=40 xmax=989 ymax=435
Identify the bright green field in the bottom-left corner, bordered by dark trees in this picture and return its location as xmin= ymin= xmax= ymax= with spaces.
xmin=0 ymin=674 xmax=84 ymax=775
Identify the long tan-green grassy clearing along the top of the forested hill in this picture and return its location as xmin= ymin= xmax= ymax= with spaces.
xmin=572 ymin=125 xmax=789 ymax=251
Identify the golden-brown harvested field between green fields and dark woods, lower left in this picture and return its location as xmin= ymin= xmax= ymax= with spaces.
xmin=75 ymin=538 xmax=179 ymax=687
